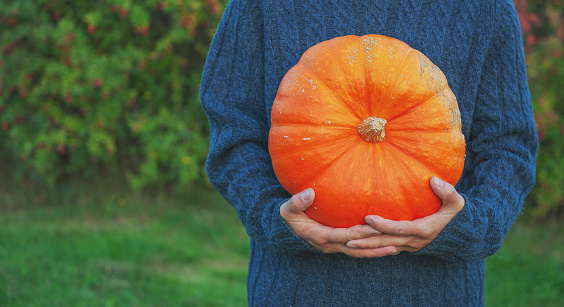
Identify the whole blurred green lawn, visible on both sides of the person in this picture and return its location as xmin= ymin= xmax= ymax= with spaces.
xmin=0 ymin=184 xmax=564 ymax=306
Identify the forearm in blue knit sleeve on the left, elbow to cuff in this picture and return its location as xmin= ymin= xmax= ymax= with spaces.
xmin=207 ymin=143 xmax=315 ymax=253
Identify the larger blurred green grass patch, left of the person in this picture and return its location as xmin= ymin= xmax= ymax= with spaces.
xmin=0 ymin=182 xmax=249 ymax=306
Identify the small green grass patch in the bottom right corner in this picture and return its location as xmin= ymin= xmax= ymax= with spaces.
xmin=486 ymin=219 xmax=564 ymax=307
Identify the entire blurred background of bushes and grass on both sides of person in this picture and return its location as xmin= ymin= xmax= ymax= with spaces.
xmin=0 ymin=0 xmax=564 ymax=306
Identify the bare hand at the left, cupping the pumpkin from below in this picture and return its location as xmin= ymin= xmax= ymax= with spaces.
xmin=280 ymin=188 xmax=397 ymax=258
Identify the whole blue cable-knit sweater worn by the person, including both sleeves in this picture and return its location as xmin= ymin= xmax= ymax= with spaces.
xmin=200 ymin=0 xmax=538 ymax=306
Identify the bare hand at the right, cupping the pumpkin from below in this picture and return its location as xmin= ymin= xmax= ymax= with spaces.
xmin=347 ymin=177 xmax=465 ymax=254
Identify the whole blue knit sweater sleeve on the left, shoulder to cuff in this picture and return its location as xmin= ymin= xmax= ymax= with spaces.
xmin=200 ymin=0 xmax=315 ymax=253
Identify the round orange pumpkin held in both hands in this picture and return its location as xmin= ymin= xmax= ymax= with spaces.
xmin=268 ymin=35 xmax=465 ymax=227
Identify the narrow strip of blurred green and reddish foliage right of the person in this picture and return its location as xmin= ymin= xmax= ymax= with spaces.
xmin=515 ymin=0 xmax=564 ymax=218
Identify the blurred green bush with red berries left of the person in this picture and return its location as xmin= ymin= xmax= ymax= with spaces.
xmin=0 ymin=0 xmax=221 ymax=188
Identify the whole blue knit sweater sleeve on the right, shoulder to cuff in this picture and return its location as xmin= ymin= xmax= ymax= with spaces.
xmin=416 ymin=3 xmax=538 ymax=261
